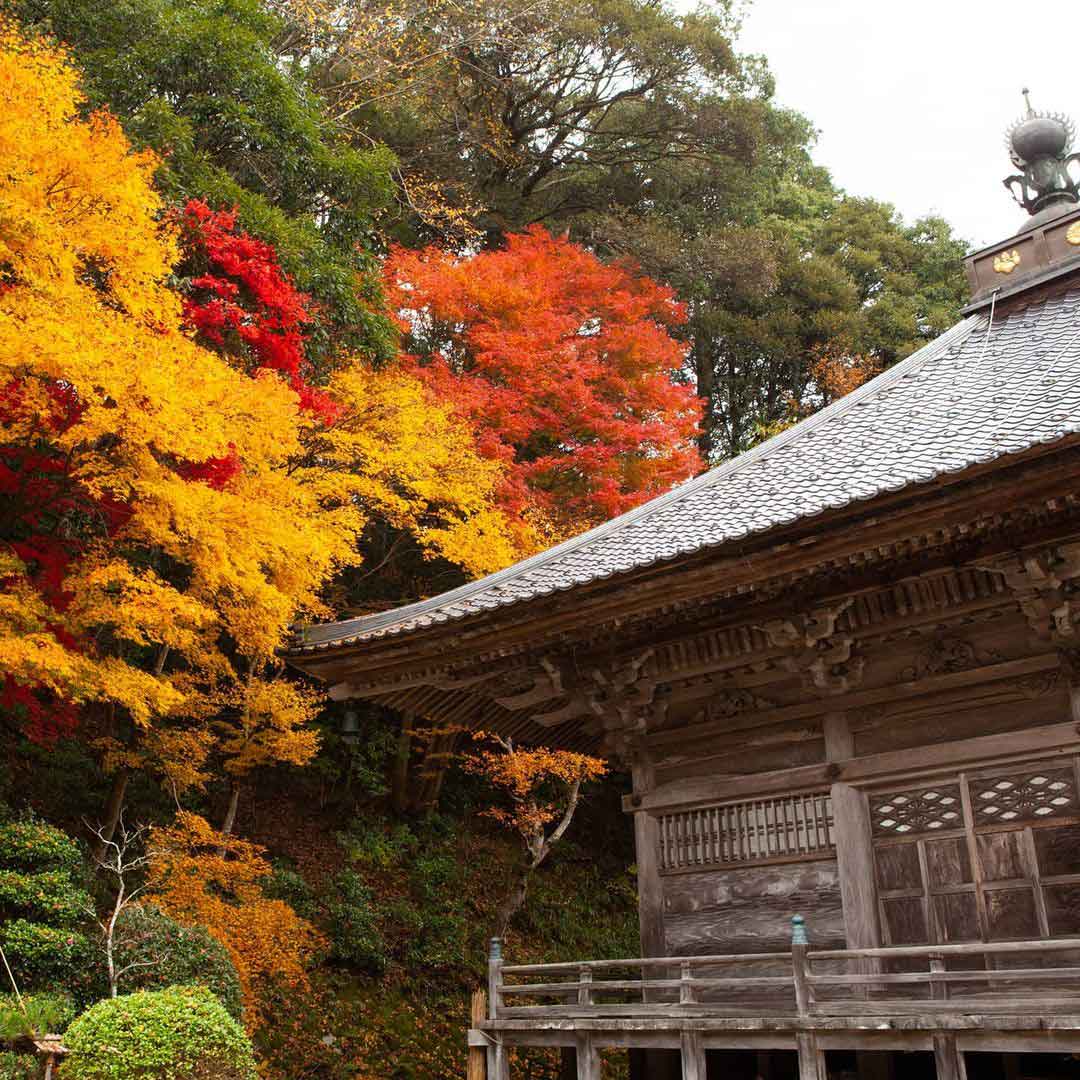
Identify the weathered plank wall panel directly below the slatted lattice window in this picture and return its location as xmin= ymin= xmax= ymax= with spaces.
xmin=663 ymin=860 xmax=845 ymax=956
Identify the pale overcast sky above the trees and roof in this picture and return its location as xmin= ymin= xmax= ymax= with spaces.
xmin=712 ymin=0 xmax=1080 ymax=245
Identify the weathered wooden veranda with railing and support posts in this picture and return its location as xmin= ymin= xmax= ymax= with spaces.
xmin=469 ymin=916 xmax=1080 ymax=1080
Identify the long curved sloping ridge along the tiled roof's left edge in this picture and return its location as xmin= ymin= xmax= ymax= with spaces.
xmin=293 ymin=313 xmax=986 ymax=650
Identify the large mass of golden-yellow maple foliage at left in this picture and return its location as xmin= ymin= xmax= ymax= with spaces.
xmin=0 ymin=23 xmax=517 ymax=803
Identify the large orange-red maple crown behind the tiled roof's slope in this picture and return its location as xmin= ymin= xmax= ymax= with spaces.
xmin=386 ymin=226 xmax=701 ymax=531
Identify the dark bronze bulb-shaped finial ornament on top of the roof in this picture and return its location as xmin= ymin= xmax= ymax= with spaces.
xmin=1002 ymin=86 xmax=1080 ymax=224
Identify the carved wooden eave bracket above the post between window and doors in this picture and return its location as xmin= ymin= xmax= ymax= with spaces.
xmin=761 ymin=596 xmax=865 ymax=694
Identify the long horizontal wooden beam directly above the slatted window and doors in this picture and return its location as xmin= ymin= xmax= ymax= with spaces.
xmin=623 ymin=720 xmax=1080 ymax=812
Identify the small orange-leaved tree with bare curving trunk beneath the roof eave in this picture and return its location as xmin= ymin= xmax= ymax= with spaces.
xmin=463 ymin=731 xmax=608 ymax=937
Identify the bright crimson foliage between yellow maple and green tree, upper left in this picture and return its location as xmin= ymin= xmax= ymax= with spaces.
xmin=180 ymin=199 xmax=338 ymax=425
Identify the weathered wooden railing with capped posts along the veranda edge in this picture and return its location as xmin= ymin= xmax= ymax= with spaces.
xmin=488 ymin=916 xmax=1080 ymax=1020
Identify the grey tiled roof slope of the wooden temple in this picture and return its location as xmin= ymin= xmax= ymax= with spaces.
xmin=291 ymin=287 xmax=1080 ymax=653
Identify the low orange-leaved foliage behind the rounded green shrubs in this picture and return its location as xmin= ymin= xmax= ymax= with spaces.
xmin=150 ymin=811 xmax=323 ymax=1030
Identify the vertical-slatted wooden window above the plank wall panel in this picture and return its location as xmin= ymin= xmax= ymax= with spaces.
xmin=660 ymin=792 xmax=834 ymax=870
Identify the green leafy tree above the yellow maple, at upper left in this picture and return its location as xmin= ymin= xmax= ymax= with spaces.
xmin=10 ymin=0 xmax=394 ymax=361
